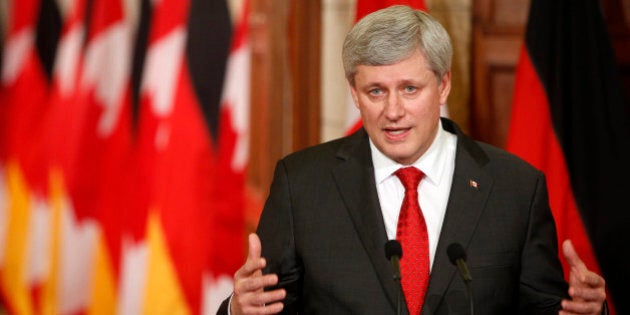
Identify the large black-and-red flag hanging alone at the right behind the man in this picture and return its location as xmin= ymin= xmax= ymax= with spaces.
xmin=507 ymin=0 xmax=630 ymax=314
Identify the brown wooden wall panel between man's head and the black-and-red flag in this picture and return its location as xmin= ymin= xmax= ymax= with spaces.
xmin=470 ymin=0 xmax=529 ymax=147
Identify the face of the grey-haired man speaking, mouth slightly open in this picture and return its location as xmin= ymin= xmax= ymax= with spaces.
xmin=351 ymin=50 xmax=451 ymax=165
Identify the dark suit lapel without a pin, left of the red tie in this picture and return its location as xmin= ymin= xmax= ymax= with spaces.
xmin=333 ymin=129 xmax=398 ymax=307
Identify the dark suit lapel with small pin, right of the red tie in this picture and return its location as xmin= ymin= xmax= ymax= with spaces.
xmin=425 ymin=120 xmax=493 ymax=313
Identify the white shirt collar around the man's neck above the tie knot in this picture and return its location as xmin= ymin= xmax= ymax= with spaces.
xmin=370 ymin=121 xmax=454 ymax=185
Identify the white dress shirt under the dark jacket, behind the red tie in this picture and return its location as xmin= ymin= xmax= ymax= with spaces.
xmin=370 ymin=122 xmax=457 ymax=268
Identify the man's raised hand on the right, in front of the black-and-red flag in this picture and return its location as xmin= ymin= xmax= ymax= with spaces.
xmin=560 ymin=240 xmax=606 ymax=315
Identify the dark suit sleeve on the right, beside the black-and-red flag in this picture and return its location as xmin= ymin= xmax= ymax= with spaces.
xmin=519 ymin=173 xmax=568 ymax=314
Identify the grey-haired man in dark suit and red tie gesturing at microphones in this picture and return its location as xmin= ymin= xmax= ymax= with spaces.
xmin=219 ymin=6 xmax=605 ymax=315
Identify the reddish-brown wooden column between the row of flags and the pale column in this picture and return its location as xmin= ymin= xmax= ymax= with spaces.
xmin=247 ymin=0 xmax=321 ymax=227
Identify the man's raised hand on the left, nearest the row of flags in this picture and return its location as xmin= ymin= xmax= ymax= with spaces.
xmin=230 ymin=233 xmax=286 ymax=315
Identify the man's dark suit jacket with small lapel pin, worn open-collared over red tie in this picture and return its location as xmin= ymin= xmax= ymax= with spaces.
xmin=220 ymin=119 xmax=567 ymax=314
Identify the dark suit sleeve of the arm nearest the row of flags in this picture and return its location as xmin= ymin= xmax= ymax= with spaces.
xmin=257 ymin=161 xmax=303 ymax=314
